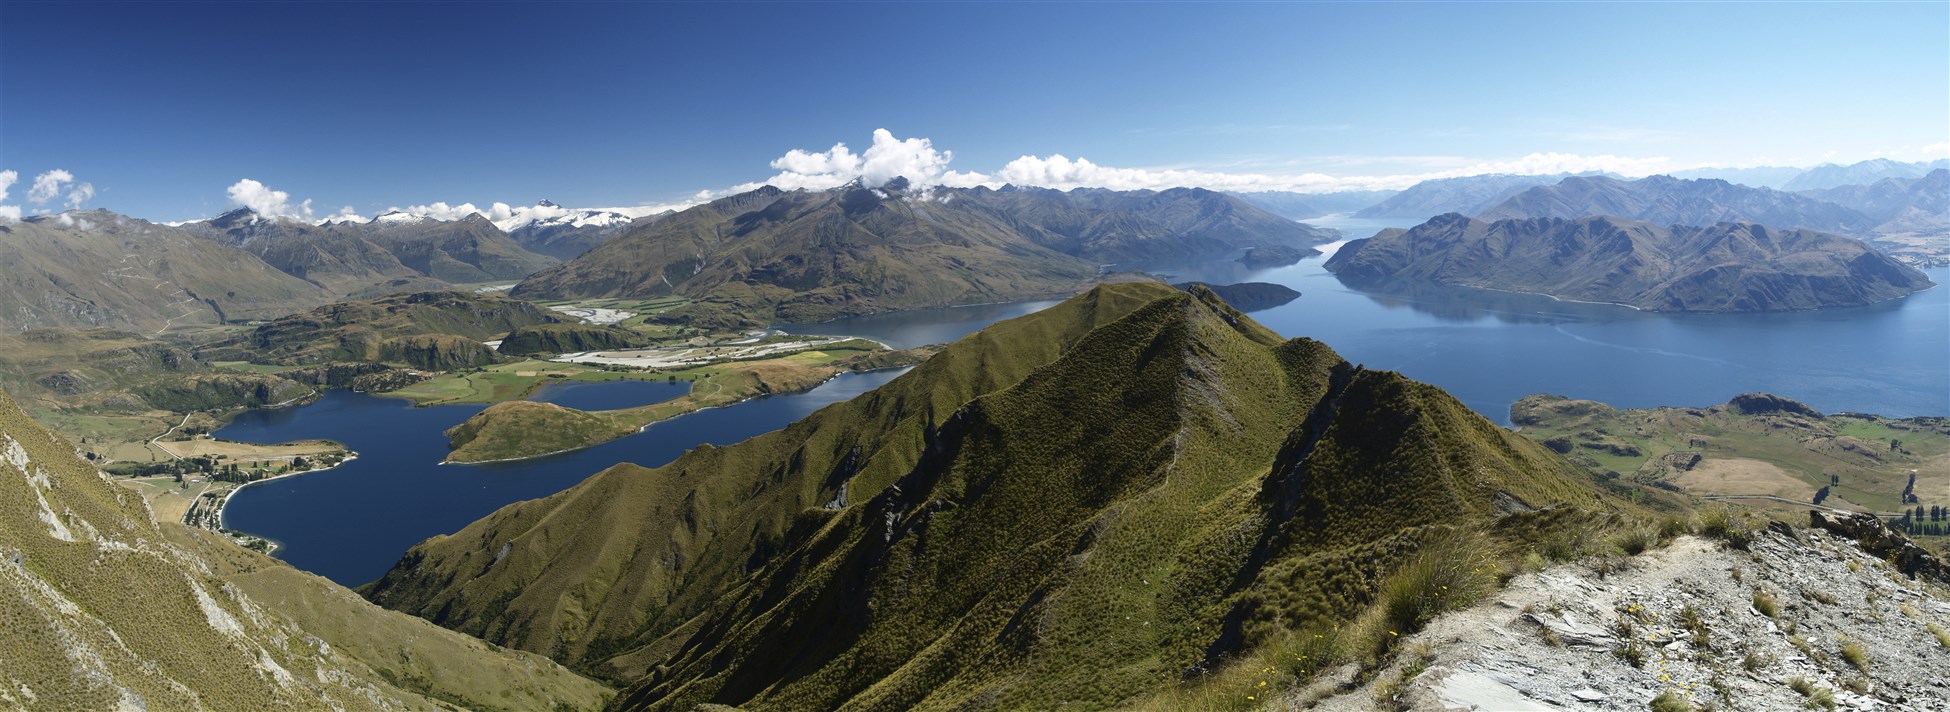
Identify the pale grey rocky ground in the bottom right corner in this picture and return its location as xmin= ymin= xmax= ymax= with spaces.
xmin=1310 ymin=523 xmax=1950 ymax=710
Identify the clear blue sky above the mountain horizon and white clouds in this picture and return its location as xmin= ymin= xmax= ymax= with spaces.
xmin=0 ymin=2 xmax=1950 ymax=220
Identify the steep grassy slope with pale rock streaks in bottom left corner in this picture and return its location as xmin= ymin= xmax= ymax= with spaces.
xmin=0 ymin=386 xmax=608 ymax=710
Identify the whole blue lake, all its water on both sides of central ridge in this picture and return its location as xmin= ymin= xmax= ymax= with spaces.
xmin=216 ymin=220 xmax=1950 ymax=585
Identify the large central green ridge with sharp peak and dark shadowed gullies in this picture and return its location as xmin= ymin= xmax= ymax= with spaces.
xmin=367 ymin=283 xmax=1609 ymax=710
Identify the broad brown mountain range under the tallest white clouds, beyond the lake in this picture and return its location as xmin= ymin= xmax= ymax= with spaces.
xmin=515 ymin=179 xmax=1332 ymax=324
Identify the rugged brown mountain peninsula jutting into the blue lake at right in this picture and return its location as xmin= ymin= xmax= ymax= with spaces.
xmin=1326 ymin=210 xmax=1931 ymax=312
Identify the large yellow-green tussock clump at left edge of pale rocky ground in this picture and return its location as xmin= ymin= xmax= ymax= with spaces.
xmin=1342 ymin=533 xmax=1500 ymax=665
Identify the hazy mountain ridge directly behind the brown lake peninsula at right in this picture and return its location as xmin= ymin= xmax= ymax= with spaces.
xmin=1478 ymin=176 xmax=1878 ymax=234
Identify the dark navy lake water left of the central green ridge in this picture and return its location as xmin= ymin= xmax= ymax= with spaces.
xmin=216 ymin=371 xmax=903 ymax=585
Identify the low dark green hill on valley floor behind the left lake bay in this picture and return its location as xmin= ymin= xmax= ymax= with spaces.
xmin=216 ymin=291 xmax=564 ymax=371
